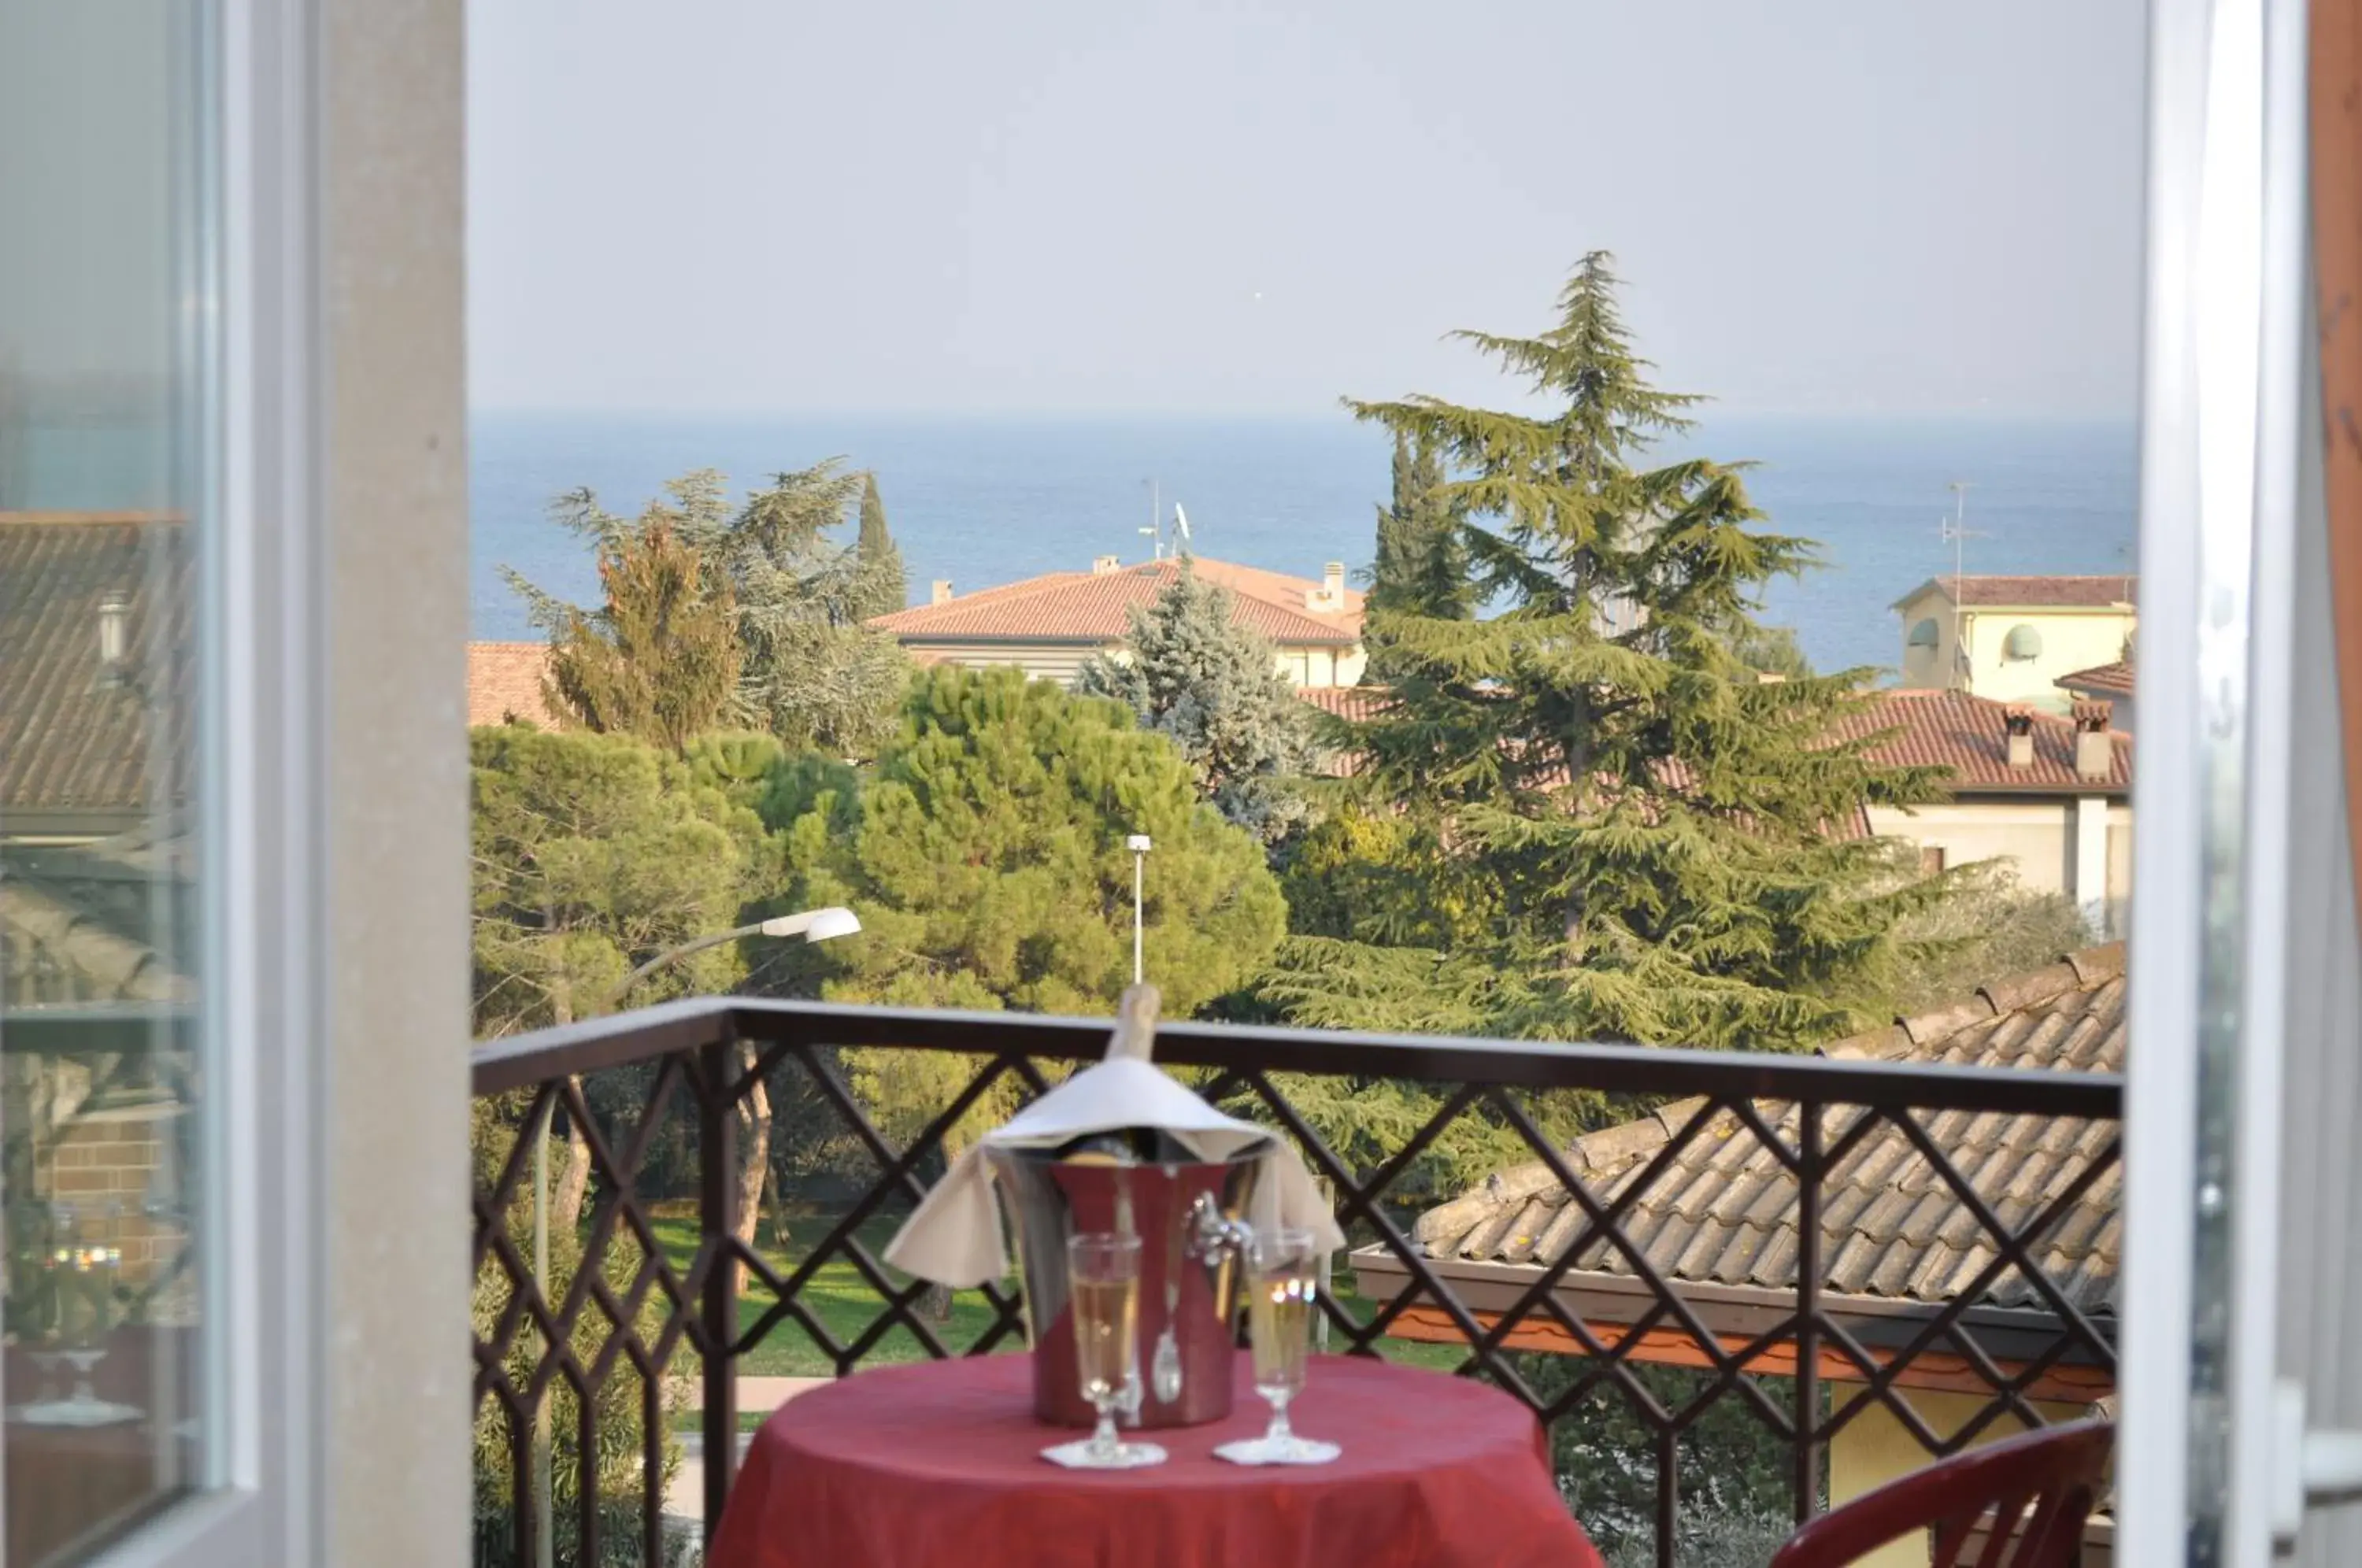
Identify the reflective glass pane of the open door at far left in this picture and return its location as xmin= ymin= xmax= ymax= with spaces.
xmin=0 ymin=0 xmax=213 ymax=1568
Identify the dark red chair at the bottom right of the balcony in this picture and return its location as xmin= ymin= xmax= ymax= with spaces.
xmin=1772 ymin=1422 xmax=2116 ymax=1568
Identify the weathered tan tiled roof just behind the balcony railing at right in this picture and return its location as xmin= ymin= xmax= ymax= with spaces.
xmin=1412 ymin=942 xmax=2126 ymax=1311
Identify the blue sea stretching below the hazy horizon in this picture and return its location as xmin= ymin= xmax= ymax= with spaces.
xmin=470 ymin=413 xmax=2138 ymax=668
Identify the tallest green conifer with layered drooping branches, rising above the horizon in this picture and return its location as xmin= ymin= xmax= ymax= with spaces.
xmin=1266 ymin=253 xmax=1942 ymax=1048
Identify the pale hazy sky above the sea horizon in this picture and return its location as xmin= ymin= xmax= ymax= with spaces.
xmin=468 ymin=0 xmax=2142 ymax=416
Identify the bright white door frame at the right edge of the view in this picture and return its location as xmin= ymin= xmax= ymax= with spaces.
xmin=2116 ymin=0 xmax=2310 ymax=1568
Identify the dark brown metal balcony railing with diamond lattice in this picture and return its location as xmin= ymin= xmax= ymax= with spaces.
xmin=475 ymin=999 xmax=2123 ymax=1566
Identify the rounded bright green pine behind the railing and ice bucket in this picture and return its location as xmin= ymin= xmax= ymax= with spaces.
xmin=763 ymin=666 xmax=1287 ymax=1091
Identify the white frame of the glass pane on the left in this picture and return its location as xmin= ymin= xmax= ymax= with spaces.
xmin=92 ymin=0 xmax=326 ymax=1568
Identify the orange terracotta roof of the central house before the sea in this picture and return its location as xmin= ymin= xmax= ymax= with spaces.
xmin=869 ymin=557 xmax=1363 ymax=647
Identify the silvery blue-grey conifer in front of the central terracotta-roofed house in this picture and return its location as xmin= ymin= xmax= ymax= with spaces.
xmin=1075 ymin=555 xmax=1311 ymax=843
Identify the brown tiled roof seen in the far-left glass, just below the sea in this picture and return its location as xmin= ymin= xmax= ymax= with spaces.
xmin=0 ymin=512 xmax=196 ymax=817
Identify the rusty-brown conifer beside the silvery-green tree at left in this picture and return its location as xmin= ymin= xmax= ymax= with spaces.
xmin=548 ymin=520 xmax=739 ymax=751
